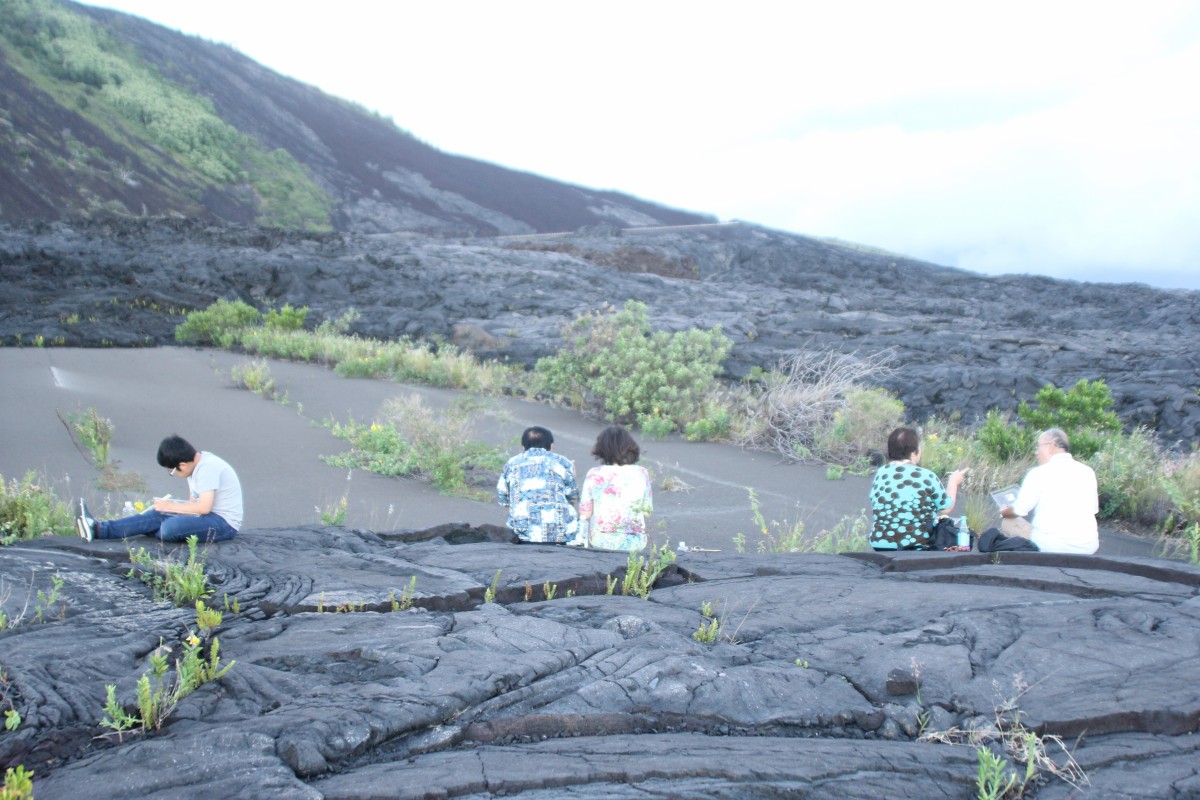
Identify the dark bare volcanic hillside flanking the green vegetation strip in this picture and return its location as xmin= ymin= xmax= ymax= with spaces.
xmin=0 ymin=1 xmax=712 ymax=235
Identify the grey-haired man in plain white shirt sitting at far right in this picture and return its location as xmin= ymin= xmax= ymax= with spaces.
xmin=1000 ymin=428 xmax=1100 ymax=554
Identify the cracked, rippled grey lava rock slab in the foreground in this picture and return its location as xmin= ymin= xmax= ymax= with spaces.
xmin=0 ymin=525 xmax=1200 ymax=800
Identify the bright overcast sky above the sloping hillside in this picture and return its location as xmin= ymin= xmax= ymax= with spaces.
xmin=82 ymin=0 xmax=1200 ymax=289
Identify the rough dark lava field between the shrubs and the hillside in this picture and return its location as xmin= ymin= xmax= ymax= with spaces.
xmin=0 ymin=221 xmax=1200 ymax=443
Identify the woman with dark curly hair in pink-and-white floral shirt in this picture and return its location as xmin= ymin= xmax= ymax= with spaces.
xmin=580 ymin=425 xmax=653 ymax=551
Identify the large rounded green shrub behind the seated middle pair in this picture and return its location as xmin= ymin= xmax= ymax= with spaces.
xmin=536 ymin=300 xmax=732 ymax=431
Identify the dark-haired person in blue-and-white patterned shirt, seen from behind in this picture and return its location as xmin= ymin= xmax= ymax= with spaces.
xmin=496 ymin=426 xmax=580 ymax=545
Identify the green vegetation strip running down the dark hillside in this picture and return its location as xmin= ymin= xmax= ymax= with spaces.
xmin=0 ymin=0 xmax=331 ymax=229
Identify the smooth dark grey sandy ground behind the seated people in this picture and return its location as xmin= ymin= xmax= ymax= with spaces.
xmin=0 ymin=348 xmax=1152 ymax=555
